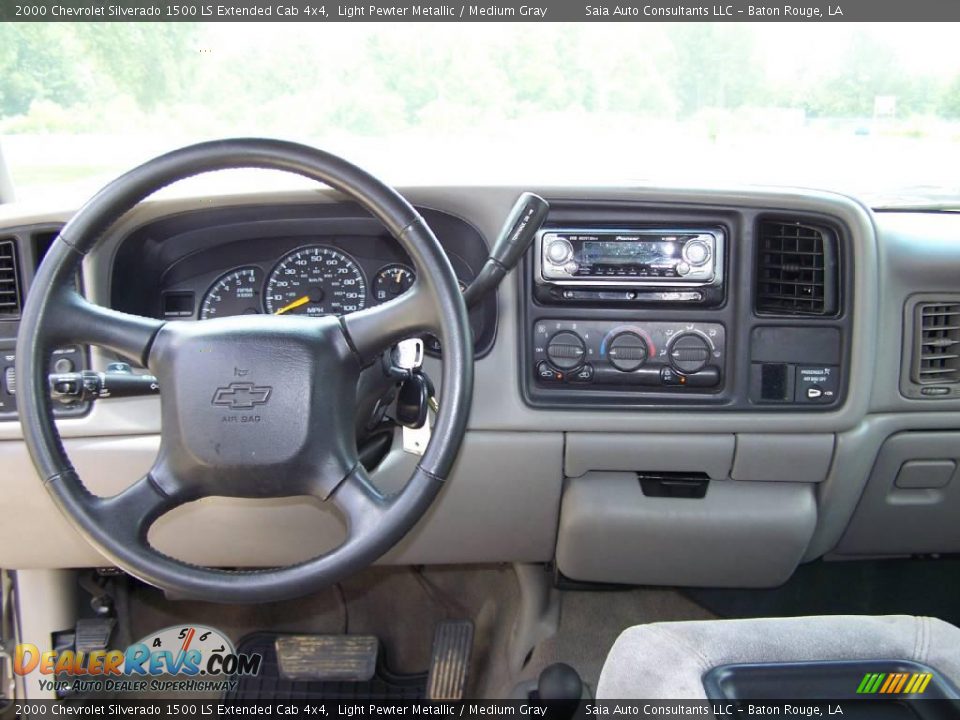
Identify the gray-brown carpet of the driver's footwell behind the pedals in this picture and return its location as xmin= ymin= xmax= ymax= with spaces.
xmin=124 ymin=565 xmax=518 ymax=697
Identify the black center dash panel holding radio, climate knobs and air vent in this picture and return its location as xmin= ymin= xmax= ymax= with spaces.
xmin=521 ymin=201 xmax=852 ymax=411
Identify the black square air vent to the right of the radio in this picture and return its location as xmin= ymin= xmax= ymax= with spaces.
xmin=756 ymin=220 xmax=837 ymax=316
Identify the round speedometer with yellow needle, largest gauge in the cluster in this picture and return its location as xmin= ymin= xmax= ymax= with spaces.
xmin=266 ymin=245 xmax=367 ymax=315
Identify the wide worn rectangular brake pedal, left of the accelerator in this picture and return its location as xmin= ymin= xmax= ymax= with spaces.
xmin=275 ymin=635 xmax=380 ymax=682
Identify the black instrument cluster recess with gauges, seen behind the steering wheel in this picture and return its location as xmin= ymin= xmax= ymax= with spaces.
xmin=106 ymin=205 xmax=496 ymax=355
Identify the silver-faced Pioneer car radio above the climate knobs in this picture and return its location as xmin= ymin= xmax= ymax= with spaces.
xmin=535 ymin=228 xmax=724 ymax=304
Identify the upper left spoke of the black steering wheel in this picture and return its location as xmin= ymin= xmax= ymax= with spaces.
xmin=51 ymin=289 xmax=164 ymax=366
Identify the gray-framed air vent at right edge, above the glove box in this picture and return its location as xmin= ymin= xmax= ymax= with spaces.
xmin=913 ymin=302 xmax=960 ymax=385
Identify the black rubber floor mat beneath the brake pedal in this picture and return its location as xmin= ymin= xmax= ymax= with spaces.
xmin=223 ymin=632 xmax=427 ymax=702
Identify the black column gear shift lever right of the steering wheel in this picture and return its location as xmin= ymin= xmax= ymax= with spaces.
xmin=463 ymin=192 xmax=550 ymax=307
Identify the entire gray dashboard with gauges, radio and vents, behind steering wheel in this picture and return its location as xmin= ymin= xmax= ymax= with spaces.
xmin=0 ymin=187 xmax=960 ymax=587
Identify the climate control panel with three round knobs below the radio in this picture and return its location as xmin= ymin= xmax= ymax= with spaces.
xmin=532 ymin=320 xmax=725 ymax=392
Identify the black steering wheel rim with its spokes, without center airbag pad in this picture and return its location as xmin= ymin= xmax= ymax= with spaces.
xmin=17 ymin=139 xmax=473 ymax=602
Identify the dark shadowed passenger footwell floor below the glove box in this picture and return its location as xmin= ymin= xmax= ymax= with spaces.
xmin=686 ymin=558 xmax=960 ymax=625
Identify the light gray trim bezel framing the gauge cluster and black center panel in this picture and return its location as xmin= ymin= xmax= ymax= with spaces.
xmin=0 ymin=185 xmax=884 ymax=439
